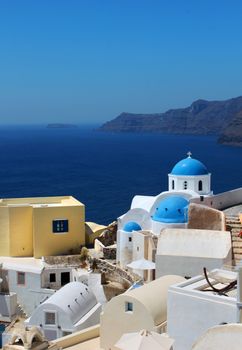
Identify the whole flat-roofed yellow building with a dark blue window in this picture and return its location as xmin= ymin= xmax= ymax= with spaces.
xmin=0 ymin=196 xmax=85 ymax=258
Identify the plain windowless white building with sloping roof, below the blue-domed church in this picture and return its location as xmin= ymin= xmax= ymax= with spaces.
xmin=156 ymin=228 xmax=232 ymax=278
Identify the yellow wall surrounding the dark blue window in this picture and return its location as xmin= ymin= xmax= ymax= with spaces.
xmin=33 ymin=205 xmax=85 ymax=258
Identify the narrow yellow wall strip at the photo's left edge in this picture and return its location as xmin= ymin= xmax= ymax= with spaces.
xmin=0 ymin=207 xmax=10 ymax=256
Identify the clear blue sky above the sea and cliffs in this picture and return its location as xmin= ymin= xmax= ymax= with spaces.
xmin=0 ymin=0 xmax=242 ymax=124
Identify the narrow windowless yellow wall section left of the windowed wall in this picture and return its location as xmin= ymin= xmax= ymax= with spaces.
xmin=9 ymin=206 xmax=33 ymax=256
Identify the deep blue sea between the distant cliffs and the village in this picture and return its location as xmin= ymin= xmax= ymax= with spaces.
xmin=0 ymin=126 xmax=242 ymax=224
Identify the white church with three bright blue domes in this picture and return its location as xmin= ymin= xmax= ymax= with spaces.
xmin=117 ymin=152 xmax=213 ymax=266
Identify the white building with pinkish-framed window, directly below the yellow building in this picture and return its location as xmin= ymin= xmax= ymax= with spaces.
xmin=0 ymin=257 xmax=91 ymax=316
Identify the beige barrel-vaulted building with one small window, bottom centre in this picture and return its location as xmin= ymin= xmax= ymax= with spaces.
xmin=100 ymin=275 xmax=184 ymax=350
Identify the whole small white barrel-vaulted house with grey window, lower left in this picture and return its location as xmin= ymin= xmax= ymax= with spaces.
xmin=26 ymin=282 xmax=102 ymax=340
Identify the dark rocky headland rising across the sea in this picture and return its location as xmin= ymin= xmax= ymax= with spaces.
xmin=100 ymin=96 xmax=242 ymax=145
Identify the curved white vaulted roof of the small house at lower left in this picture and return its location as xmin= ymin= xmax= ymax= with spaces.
xmin=42 ymin=282 xmax=97 ymax=324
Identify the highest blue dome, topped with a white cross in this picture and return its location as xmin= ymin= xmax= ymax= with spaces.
xmin=171 ymin=153 xmax=208 ymax=176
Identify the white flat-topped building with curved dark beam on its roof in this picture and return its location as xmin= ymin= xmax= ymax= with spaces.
xmin=167 ymin=269 xmax=237 ymax=350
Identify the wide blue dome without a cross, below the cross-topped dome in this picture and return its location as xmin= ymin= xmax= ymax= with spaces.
xmin=152 ymin=196 xmax=189 ymax=223
